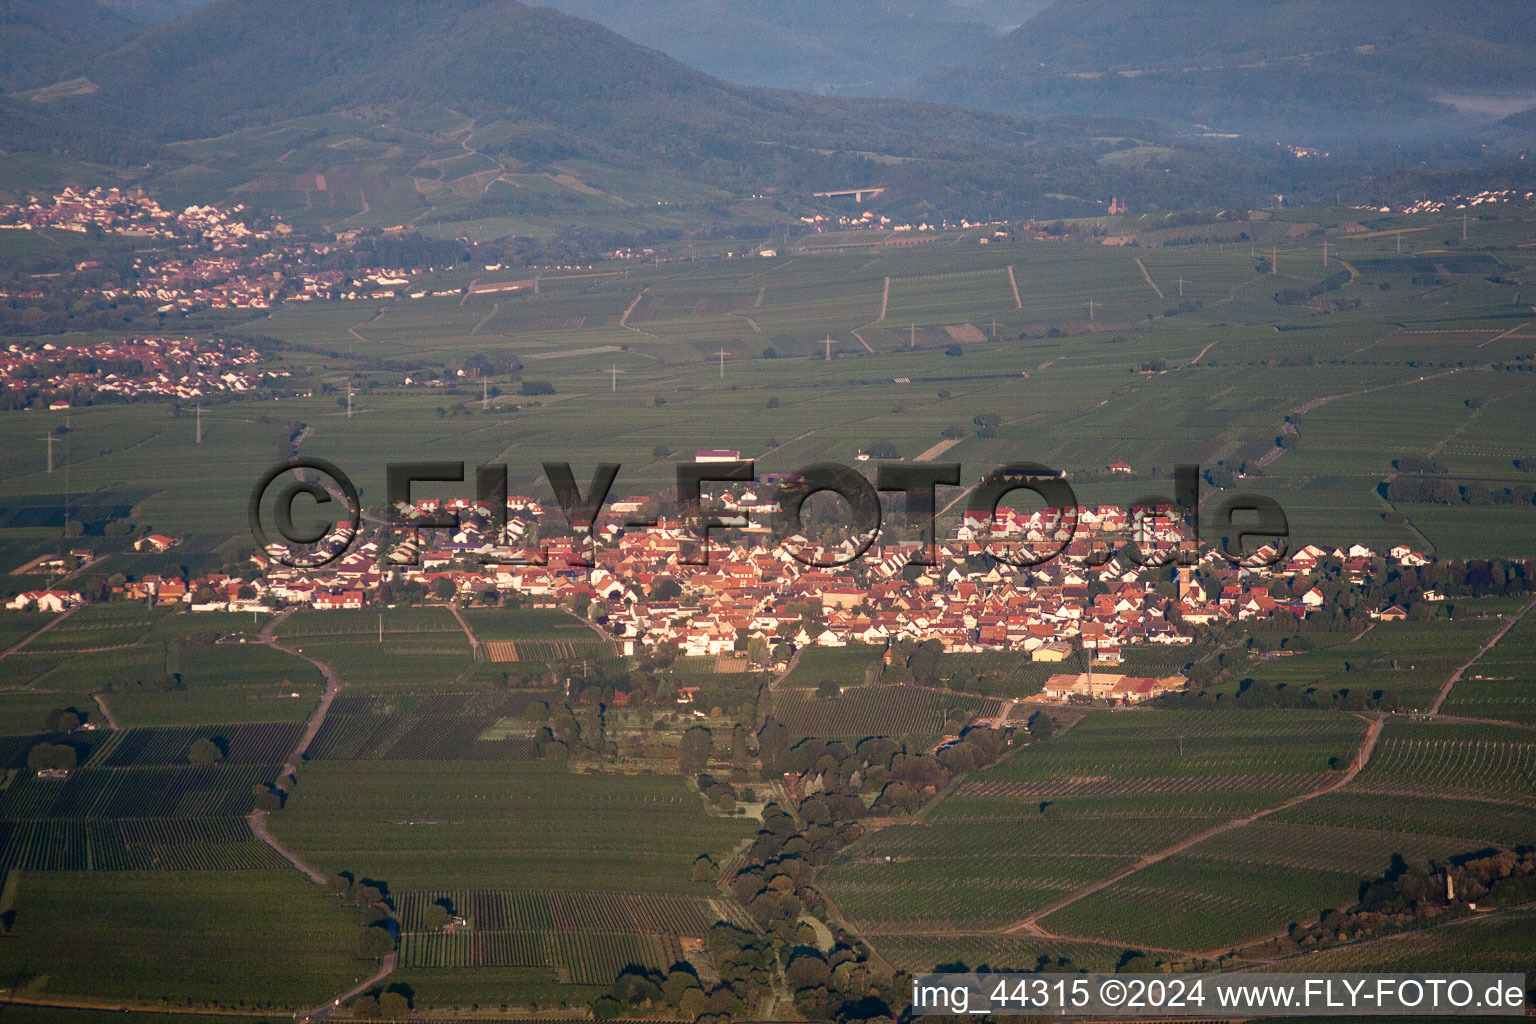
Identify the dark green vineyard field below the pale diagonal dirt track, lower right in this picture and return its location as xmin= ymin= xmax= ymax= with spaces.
xmin=1019 ymin=722 xmax=1536 ymax=952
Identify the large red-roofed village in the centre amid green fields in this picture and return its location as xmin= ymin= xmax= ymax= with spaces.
xmin=8 ymin=460 xmax=1441 ymax=705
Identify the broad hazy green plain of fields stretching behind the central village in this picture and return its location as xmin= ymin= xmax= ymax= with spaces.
xmin=0 ymin=212 xmax=1536 ymax=561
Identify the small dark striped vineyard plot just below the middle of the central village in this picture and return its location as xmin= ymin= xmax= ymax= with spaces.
xmin=773 ymin=686 xmax=1001 ymax=742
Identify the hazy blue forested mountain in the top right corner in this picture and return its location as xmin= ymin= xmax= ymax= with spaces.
xmin=919 ymin=0 xmax=1536 ymax=144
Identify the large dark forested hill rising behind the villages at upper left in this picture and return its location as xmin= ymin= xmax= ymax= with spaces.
xmin=0 ymin=0 xmax=1320 ymax=233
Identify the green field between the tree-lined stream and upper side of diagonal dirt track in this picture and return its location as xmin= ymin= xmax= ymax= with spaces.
xmin=825 ymin=711 xmax=1366 ymax=949
